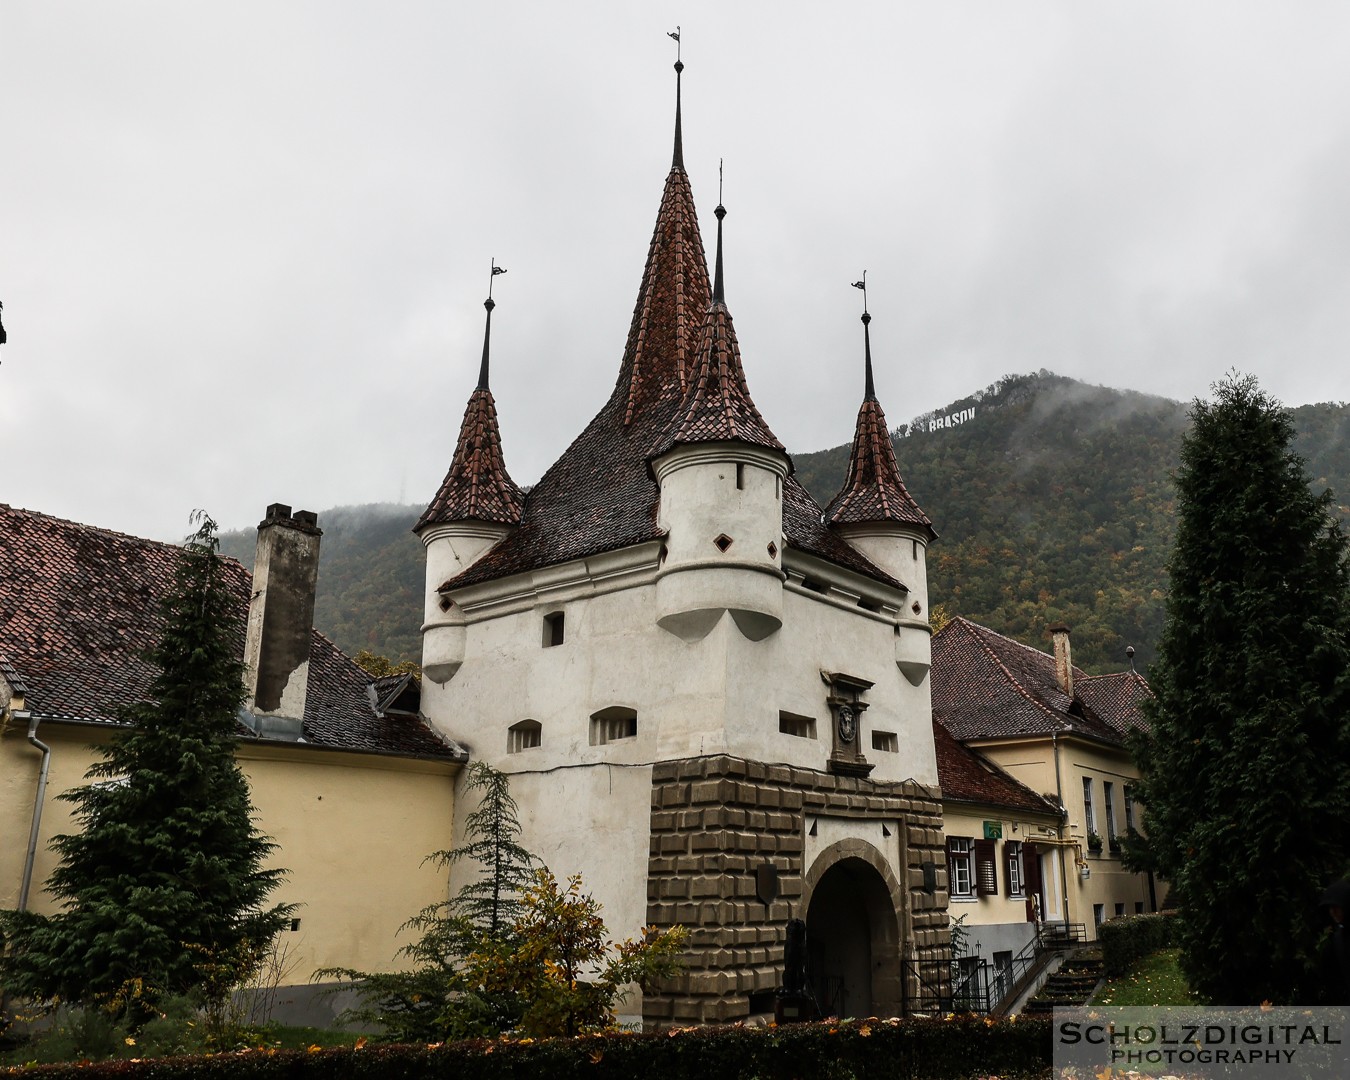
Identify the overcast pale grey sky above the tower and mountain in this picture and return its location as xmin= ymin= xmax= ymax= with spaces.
xmin=0 ymin=0 xmax=1350 ymax=539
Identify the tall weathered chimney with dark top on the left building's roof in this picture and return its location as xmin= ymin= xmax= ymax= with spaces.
xmin=244 ymin=502 xmax=323 ymax=737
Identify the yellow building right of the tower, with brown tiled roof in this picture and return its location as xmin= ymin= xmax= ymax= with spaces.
xmin=933 ymin=618 xmax=1161 ymax=940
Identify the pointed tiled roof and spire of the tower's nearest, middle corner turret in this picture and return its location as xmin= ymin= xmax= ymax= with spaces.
xmin=656 ymin=203 xmax=783 ymax=454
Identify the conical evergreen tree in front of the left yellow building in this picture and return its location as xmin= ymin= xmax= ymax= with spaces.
xmin=3 ymin=514 xmax=290 ymax=1019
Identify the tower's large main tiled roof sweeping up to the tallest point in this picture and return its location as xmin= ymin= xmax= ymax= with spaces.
xmin=441 ymin=162 xmax=895 ymax=589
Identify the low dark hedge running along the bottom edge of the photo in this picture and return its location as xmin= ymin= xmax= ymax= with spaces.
xmin=2 ymin=1017 xmax=1050 ymax=1080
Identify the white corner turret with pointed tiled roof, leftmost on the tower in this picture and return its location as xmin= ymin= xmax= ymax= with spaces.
xmin=413 ymin=262 xmax=525 ymax=683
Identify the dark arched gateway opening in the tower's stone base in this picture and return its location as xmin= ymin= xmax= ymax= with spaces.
xmin=805 ymin=840 xmax=905 ymax=1017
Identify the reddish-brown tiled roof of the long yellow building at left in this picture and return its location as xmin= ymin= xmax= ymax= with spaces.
xmin=0 ymin=504 xmax=463 ymax=760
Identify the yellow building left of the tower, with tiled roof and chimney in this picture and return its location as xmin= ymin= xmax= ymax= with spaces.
xmin=0 ymin=505 xmax=467 ymax=1022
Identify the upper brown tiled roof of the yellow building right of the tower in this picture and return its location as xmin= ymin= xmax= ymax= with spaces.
xmin=932 ymin=618 xmax=1148 ymax=744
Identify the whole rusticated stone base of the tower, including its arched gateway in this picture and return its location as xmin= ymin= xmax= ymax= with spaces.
xmin=643 ymin=756 xmax=950 ymax=1027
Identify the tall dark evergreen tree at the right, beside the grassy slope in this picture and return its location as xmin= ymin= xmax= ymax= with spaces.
xmin=1137 ymin=377 xmax=1350 ymax=1004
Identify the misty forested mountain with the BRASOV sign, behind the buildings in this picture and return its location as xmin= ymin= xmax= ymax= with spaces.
xmin=221 ymin=371 xmax=1350 ymax=672
